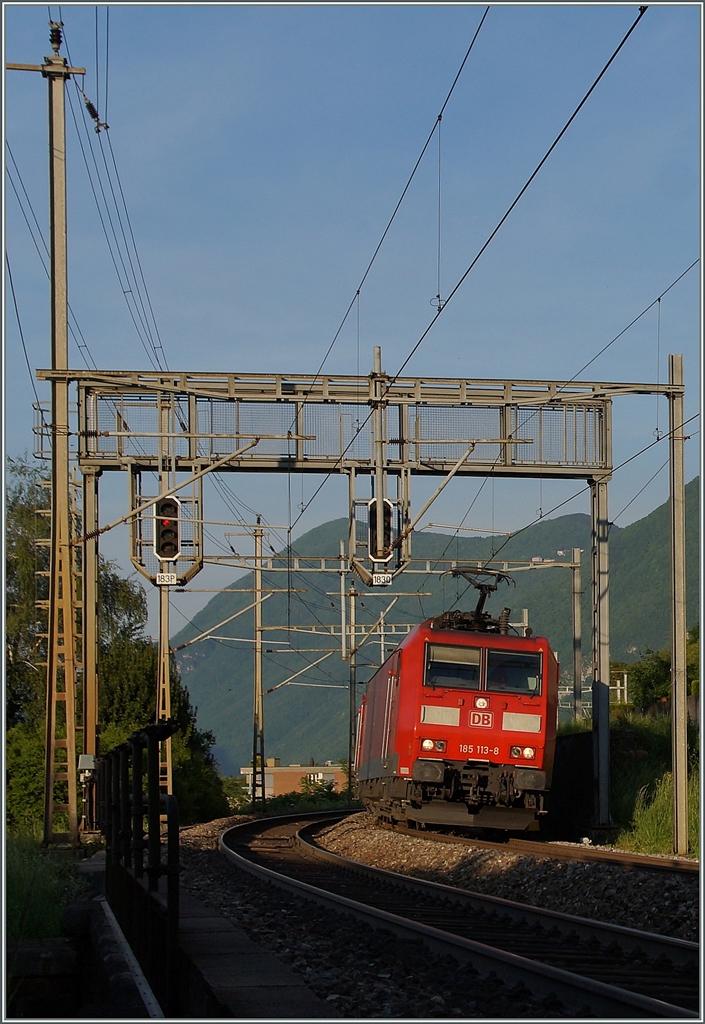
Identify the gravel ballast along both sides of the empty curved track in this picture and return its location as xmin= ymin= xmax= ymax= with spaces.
xmin=180 ymin=814 xmax=698 ymax=1019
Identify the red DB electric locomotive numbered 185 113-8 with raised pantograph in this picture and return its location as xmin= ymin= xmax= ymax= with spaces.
xmin=356 ymin=569 xmax=558 ymax=829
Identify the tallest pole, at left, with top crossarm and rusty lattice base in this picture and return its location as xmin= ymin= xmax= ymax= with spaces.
xmin=7 ymin=22 xmax=85 ymax=846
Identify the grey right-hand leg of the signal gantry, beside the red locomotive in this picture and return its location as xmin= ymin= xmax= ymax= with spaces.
xmin=590 ymin=479 xmax=611 ymax=827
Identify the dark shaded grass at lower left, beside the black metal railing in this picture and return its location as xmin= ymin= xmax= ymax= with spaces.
xmin=5 ymin=836 xmax=86 ymax=942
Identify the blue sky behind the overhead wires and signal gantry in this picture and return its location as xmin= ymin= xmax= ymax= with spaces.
xmin=3 ymin=4 xmax=702 ymax=626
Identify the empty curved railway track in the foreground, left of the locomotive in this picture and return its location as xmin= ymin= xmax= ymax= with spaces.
xmin=220 ymin=812 xmax=699 ymax=1019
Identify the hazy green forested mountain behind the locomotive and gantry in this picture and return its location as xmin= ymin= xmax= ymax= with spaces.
xmin=173 ymin=478 xmax=700 ymax=774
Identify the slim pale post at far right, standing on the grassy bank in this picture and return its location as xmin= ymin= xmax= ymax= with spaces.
xmin=668 ymin=354 xmax=688 ymax=854
